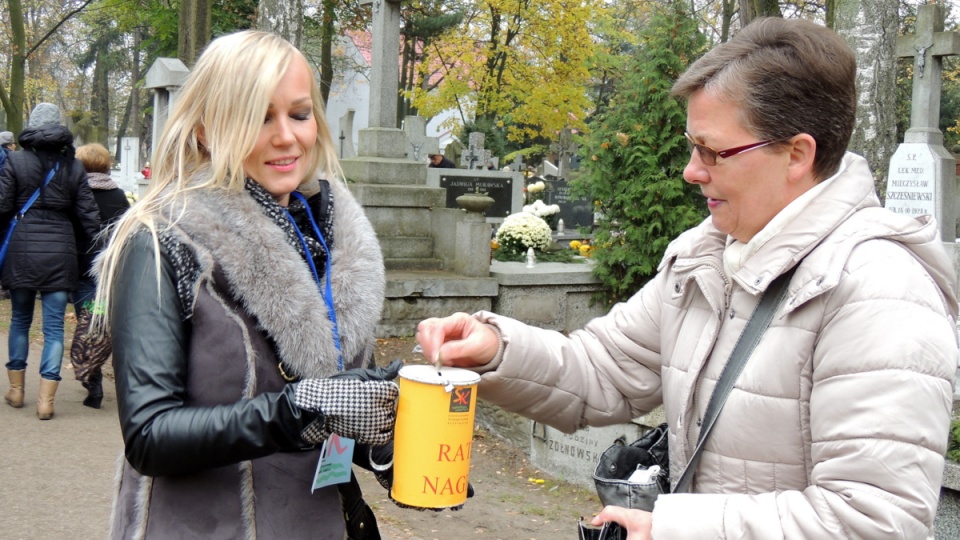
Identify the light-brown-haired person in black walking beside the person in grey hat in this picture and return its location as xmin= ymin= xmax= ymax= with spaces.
xmin=70 ymin=143 xmax=130 ymax=409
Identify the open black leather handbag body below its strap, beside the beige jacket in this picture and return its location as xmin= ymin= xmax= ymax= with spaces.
xmin=593 ymin=423 xmax=670 ymax=512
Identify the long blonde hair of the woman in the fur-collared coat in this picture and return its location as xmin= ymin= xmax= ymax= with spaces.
xmin=94 ymin=30 xmax=343 ymax=331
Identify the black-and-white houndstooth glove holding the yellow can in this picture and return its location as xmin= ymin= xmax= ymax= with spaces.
xmin=295 ymin=374 xmax=400 ymax=445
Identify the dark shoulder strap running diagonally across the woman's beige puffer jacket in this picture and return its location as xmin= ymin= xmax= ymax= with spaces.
xmin=673 ymin=264 xmax=800 ymax=493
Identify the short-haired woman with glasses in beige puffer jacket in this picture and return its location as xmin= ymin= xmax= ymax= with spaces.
xmin=417 ymin=18 xmax=958 ymax=540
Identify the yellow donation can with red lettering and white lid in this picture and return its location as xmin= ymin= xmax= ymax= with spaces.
xmin=390 ymin=365 xmax=480 ymax=508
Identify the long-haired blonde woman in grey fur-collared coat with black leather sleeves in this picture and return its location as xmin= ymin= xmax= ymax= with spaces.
xmin=94 ymin=31 xmax=399 ymax=540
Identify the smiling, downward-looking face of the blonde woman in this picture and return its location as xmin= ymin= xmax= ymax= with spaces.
xmin=243 ymin=57 xmax=317 ymax=206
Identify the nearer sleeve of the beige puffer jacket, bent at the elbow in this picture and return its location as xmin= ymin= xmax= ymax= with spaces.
xmin=653 ymin=241 xmax=958 ymax=539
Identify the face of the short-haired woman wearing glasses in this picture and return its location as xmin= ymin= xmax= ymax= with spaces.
xmin=683 ymin=90 xmax=796 ymax=242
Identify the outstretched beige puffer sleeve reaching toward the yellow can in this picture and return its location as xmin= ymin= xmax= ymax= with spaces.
xmin=475 ymin=273 xmax=665 ymax=433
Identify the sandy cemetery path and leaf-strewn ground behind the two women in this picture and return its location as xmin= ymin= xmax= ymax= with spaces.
xmin=0 ymin=300 xmax=601 ymax=540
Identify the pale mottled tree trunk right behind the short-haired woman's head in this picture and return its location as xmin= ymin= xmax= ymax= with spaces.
xmin=834 ymin=0 xmax=900 ymax=191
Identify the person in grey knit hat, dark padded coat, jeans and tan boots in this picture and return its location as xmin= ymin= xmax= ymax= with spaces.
xmin=0 ymin=103 xmax=100 ymax=420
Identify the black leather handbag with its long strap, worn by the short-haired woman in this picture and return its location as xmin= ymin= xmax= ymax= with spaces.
xmin=593 ymin=263 xmax=799 ymax=512
